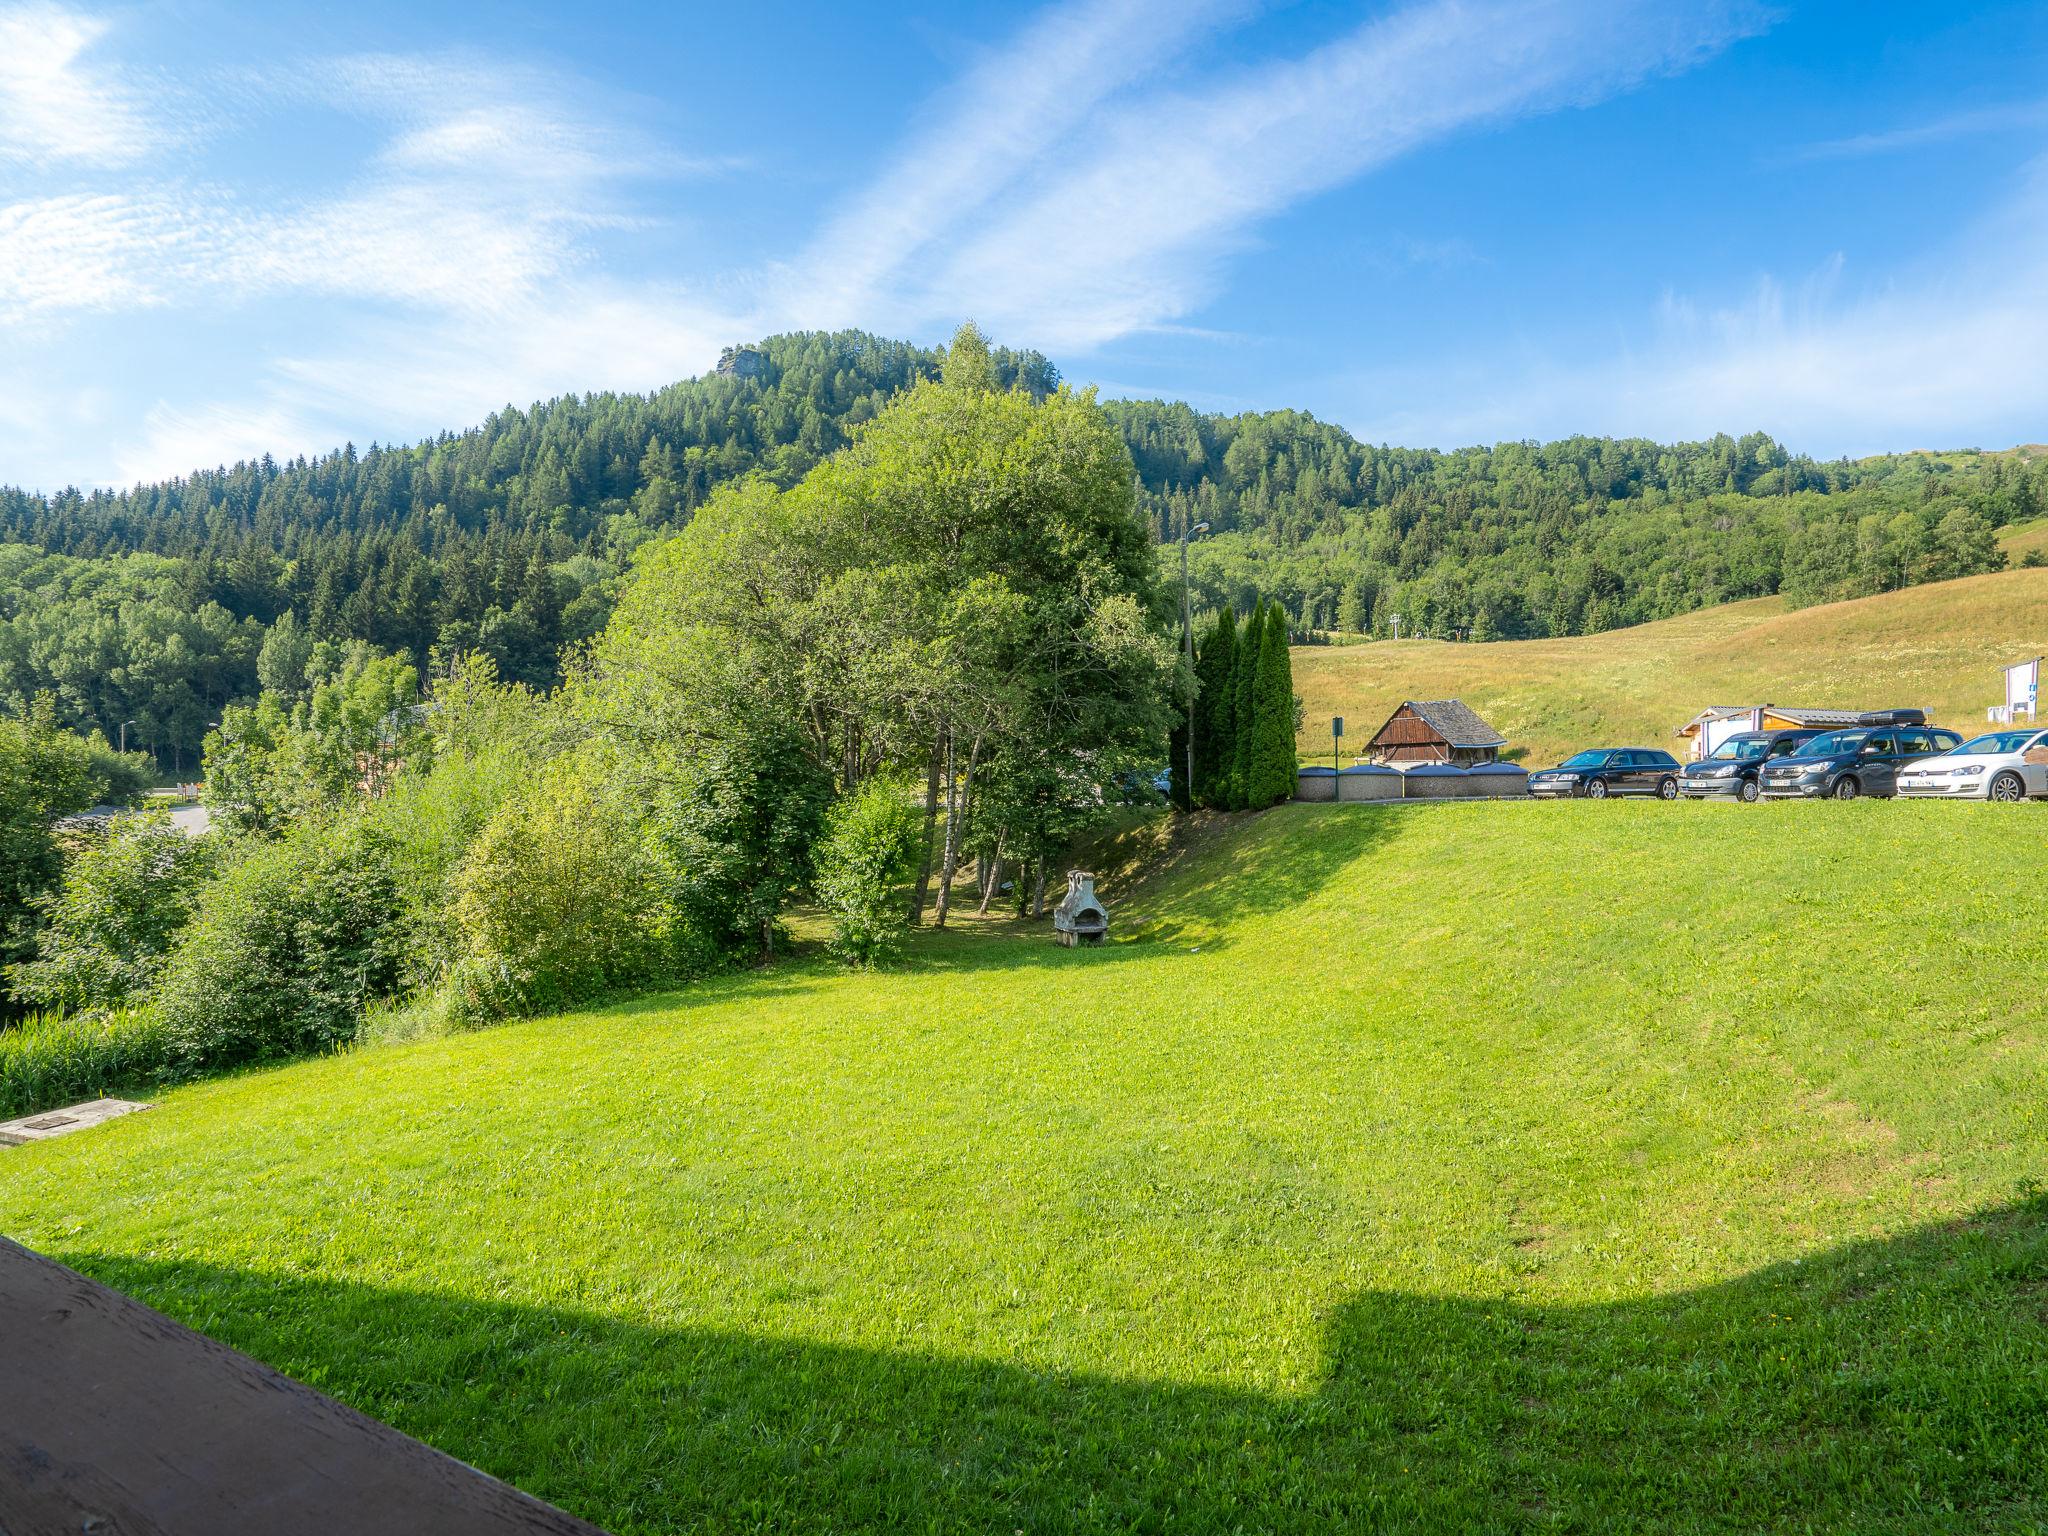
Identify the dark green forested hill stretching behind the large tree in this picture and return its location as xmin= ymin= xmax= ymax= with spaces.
xmin=0 ymin=332 xmax=2048 ymax=770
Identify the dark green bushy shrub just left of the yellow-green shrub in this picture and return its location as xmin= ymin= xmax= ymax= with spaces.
xmin=156 ymin=817 xmax=403 ymax=1067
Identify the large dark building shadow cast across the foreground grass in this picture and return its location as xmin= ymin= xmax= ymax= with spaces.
xmin=55 ymin=1200 xmax=2048 ymax=1532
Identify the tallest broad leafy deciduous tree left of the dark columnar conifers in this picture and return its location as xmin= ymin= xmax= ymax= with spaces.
xmin=578 ymin=326 xmax=1190 ymax=922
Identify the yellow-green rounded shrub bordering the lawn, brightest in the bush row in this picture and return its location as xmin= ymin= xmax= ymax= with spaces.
xmin=451 ymin=762 xmax=692 ymax=1018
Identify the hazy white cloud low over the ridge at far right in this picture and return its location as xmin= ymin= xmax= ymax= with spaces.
xmin=1339 ymin=160 xmax=2048 ymax=457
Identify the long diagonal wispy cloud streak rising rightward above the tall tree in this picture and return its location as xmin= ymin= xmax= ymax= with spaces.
xmin=806 ymin=0 xmax=1765 ymax=348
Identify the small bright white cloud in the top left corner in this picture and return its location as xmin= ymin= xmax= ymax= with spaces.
xmin=0 ymin=4 xmax=162 ymax=168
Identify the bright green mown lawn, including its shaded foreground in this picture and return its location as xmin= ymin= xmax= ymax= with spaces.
xmin=0 ymin=803 xmax=2048 ymax=1532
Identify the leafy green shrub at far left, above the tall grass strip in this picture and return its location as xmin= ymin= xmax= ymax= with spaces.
xmin=8 ymin=815 xmax=213 ymax=1014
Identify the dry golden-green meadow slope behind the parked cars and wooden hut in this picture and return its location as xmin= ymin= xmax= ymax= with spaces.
xmin=1294 ymin=569 xmax=2048 ymax=764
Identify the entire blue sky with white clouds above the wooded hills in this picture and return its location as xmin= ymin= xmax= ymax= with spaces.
xmin=0 ymin=0 xmax=2048 ymax=489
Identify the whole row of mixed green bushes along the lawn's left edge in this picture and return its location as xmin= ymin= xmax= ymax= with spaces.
xmin=0 ymin=663 xmax=922 ymax=1112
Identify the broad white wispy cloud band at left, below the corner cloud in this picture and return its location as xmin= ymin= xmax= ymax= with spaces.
xmin=0 ymin=47 xmax=702 ymax=322
